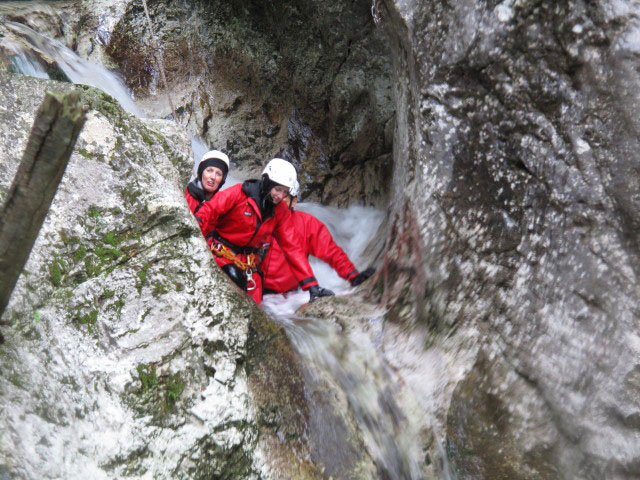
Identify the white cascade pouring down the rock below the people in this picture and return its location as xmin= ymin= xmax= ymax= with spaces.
xmin=274 ymin=307 xmax=423 ymax=480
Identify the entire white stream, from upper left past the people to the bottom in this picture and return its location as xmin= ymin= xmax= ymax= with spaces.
xmin=4 ymin=18 xmax=449 ymax=480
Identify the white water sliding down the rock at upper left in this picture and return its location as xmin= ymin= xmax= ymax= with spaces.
xmin=5 ymin=22 xmax=144 ymax=118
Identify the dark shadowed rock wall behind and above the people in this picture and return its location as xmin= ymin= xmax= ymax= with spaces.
xmin=94 ymin=0 xmax=393 ymax=205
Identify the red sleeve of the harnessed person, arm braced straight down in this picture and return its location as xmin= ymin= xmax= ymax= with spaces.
xmin=273 ymin=203 xmax=318 ymax=290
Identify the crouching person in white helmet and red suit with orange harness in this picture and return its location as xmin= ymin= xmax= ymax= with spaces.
xmin=196 ymin=158 xmax=333 ymax=303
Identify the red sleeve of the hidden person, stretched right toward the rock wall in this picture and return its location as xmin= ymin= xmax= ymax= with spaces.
xmin=302 ymin=212 xmax=358 ymax=280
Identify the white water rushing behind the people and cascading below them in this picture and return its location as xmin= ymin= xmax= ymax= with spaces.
xmin=264 ymin=203 xmax=432 ymax=480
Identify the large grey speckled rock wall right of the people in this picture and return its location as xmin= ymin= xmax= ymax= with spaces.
xmin=374 ymin=0 xmax=640 ymax=479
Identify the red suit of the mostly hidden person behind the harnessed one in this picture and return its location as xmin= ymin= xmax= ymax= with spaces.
xmin=262 ymin=212 xmax=358 ymax=293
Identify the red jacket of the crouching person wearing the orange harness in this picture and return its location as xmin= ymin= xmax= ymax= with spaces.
xmin=196 ymin=182 xmax=318 ymax=290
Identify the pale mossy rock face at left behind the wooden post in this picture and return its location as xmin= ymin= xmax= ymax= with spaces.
xmin=0 ymin=72 xmax=350 ymax=480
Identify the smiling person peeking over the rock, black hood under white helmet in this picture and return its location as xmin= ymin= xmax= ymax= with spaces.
xmin=184 ymin=150 xmax=229 ymax=215
